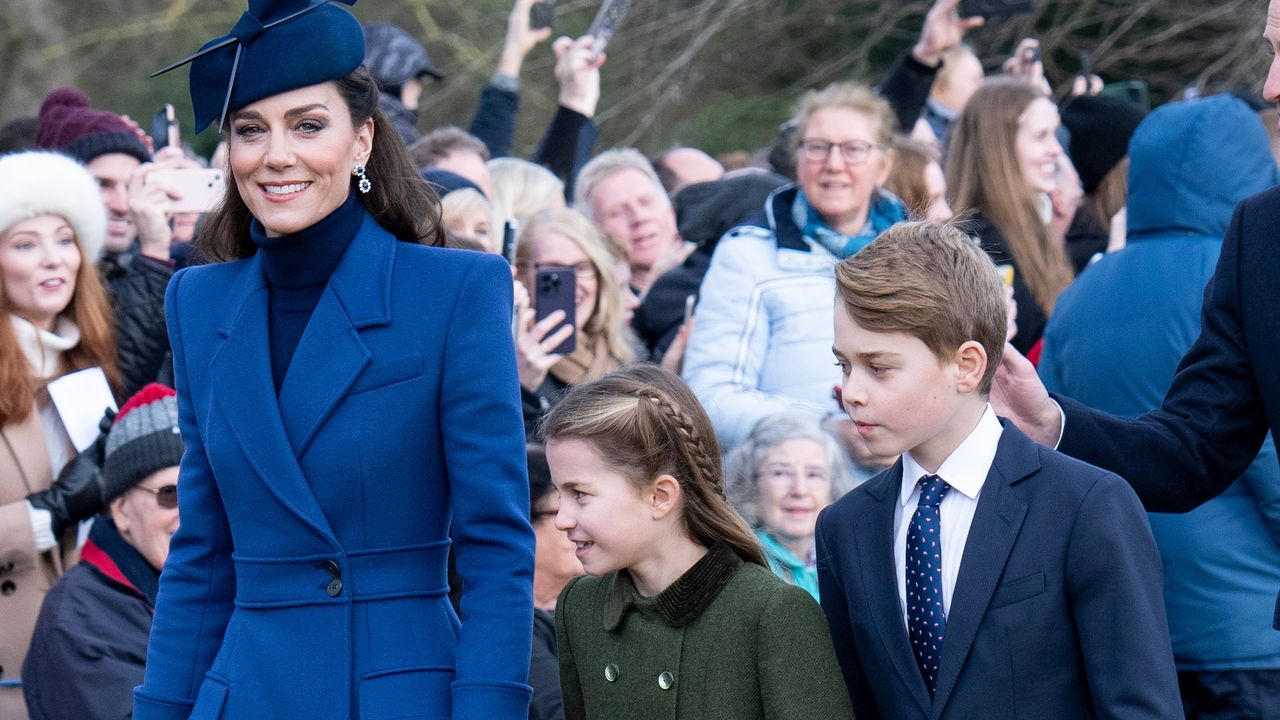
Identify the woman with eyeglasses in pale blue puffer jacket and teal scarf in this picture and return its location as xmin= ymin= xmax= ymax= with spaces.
xmin=684 ymin=83 xmax=906 ymax=464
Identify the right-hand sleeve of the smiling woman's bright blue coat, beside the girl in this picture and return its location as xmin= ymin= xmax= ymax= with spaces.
xmin=440 ymin=255 xmax=534 ymax=720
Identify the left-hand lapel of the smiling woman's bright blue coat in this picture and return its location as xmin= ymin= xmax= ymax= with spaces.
xmin=210 ymin=249 xmax=333 ymax=542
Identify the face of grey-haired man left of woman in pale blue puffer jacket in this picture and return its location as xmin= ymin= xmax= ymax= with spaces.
xmin=588 ymin=168 xmax=680 ymax=273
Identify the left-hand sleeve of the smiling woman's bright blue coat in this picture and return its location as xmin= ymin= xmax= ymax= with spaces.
xmin=133 ymin=270 xmax=236 ymax=720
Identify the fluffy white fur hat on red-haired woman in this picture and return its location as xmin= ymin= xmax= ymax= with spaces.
xmin=0 ymin=152 xmax=106 ymax=263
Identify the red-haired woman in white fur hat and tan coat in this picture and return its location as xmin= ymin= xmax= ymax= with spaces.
xmin=0 ymin=152 xmax=119 ymax=719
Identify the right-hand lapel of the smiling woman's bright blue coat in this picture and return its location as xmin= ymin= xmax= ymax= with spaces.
xmin=280 ymin=217 xmax=397 ymax=457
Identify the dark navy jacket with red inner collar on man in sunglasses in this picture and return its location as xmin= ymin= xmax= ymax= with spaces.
xmin=22 ymin=518 xmax=159 ymax=720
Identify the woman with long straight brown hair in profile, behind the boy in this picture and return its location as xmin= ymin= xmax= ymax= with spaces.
xmin=946 ymin=77 xmax=1075 ymax=354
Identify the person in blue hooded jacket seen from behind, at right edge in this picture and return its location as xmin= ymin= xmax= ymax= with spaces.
xmin=1039 ymin=95 xmax=1280 ymax=719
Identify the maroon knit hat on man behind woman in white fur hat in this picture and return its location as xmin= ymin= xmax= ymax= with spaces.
xmin=36 ymin=87 xmax=151 ymax=163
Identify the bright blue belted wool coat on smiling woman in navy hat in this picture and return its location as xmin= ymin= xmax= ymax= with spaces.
xmin=134 ymin=217 xmax=534 ymax=720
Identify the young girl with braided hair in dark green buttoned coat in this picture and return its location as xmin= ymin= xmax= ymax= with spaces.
xmin=543 ymin=365 xmax=852 ymax=720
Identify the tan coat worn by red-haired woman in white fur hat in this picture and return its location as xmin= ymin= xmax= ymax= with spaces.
xmin=0 ymin=400 xmax=76 ymax=720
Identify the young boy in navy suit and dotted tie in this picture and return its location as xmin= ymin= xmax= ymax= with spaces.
xmin=817 ymin=223 xmax=1183 ymax=720
